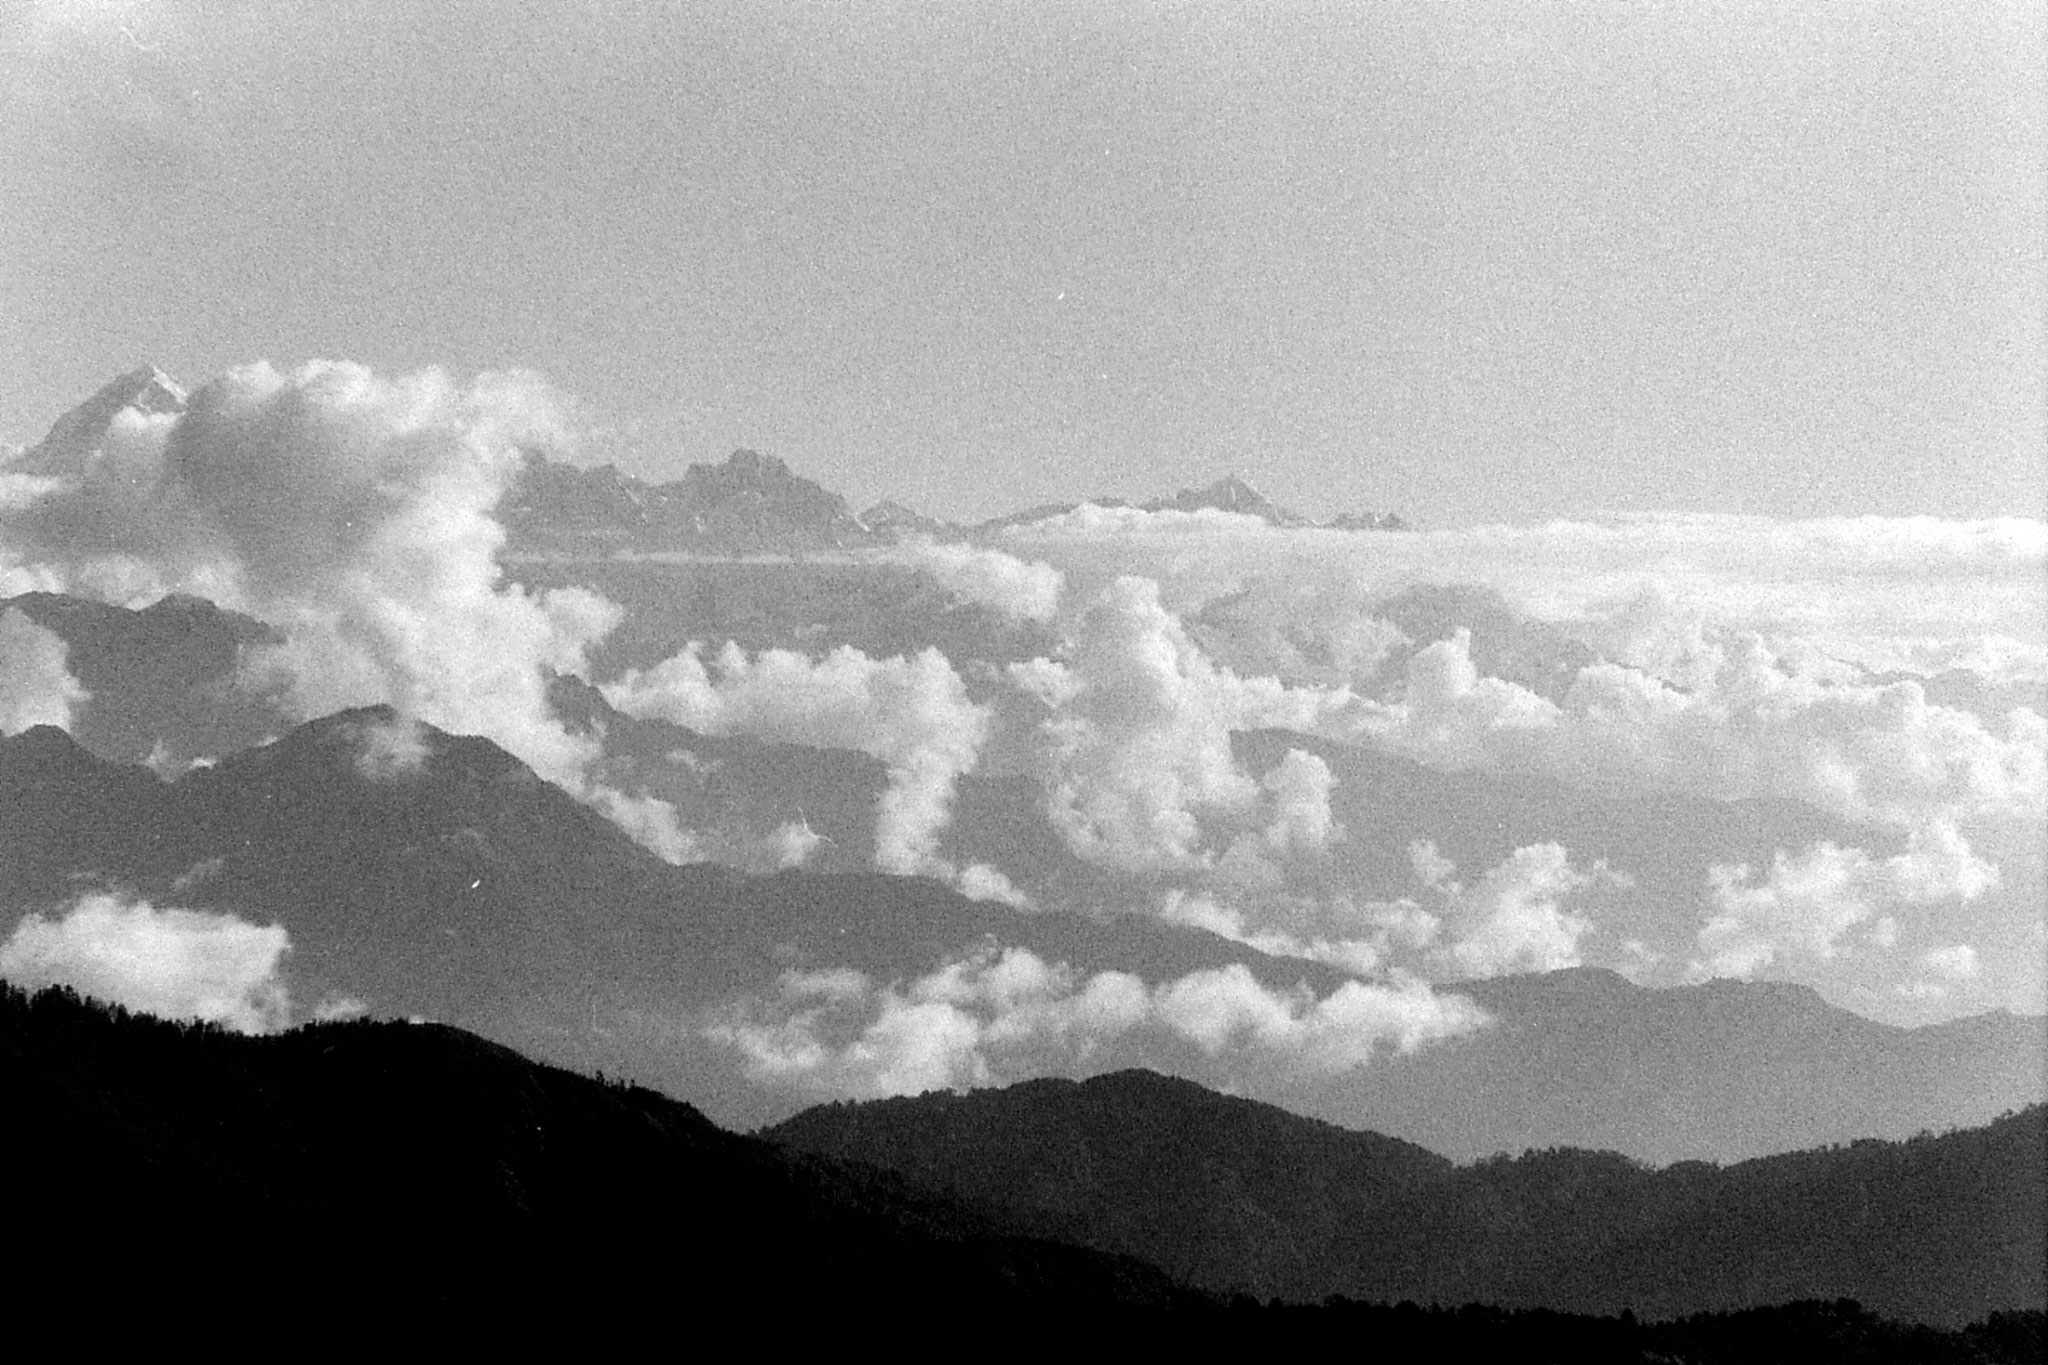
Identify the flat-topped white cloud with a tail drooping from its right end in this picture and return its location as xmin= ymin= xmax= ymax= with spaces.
xmin=604 ymin=643 xmax=989 ymax=876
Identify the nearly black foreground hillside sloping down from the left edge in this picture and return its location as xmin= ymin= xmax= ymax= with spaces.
xmin=0 ymin=988 xmax=2044 ymax=1365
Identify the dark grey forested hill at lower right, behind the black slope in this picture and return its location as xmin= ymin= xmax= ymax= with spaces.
xmin=766 ymin=1072 xmax=2048 ymax=1324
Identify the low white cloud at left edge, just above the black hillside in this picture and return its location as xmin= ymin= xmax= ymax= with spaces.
xmin=0 ymin=894 xmax=291 ymax=1033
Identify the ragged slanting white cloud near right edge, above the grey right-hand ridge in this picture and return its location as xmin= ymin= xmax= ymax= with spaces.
xmin=1694 ymin=825 xmax=1999 ymax=976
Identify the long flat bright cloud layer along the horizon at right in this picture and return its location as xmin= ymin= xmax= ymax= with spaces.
xmin=1004 ymin=508 xmax=2048 ymax=677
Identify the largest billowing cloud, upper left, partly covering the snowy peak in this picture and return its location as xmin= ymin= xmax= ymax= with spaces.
xmin=4 ymin=360 xmax=696 ymax=859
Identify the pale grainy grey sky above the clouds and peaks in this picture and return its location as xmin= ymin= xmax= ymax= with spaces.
xmin=0 ymin=0 xmax=2048 ymax=524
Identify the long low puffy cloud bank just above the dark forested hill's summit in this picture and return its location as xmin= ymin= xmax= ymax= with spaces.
xmin=707 ymin=945 xmax=1487 ymax=1097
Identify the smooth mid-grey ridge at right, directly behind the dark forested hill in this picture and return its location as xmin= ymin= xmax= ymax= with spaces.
xmin=1294 ymin=968 xmax=2048 ymax=1162
